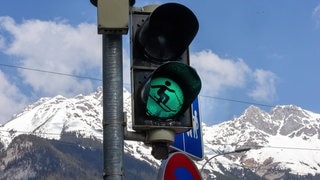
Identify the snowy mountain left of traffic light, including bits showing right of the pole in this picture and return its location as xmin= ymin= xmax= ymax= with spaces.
xmin=0 ymin=88 xmax=160 ymax=170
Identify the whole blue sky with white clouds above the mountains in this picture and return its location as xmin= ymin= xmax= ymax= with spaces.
xmin=0 ymin=0 xmax=320 ymax=124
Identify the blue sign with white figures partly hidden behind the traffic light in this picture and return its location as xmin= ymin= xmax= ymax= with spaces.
xmin=171 ymin=98 xmax=203 ymax=160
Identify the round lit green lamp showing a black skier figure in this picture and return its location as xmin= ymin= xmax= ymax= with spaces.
xmin=147 ymin=77 xmax=184 ymax=119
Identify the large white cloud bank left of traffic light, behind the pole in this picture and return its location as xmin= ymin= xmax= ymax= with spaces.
xmin=0 ymin=17 xmax=134 ymax=123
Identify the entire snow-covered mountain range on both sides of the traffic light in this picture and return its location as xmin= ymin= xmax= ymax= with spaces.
xmin=0 ymin=88 xmax=320 ymax=179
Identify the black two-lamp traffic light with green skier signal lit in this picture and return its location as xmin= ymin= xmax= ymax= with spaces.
xmin=130 ymin=3 xmax=201 ymax=133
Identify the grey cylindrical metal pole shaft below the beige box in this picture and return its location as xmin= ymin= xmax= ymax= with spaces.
xmin=102 ymin=34 xmax=124 ymax=180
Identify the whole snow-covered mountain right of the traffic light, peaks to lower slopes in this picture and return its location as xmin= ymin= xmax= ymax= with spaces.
xmin=203 ymin=105 xmax=320 ymax=179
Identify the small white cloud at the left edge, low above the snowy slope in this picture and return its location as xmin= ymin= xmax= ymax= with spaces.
xmin=0 ymin=71 xmax=26 ymax=124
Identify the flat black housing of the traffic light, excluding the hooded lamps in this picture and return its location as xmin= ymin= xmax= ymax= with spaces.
xmin=130 ymin=2 xmax=200 ymax=133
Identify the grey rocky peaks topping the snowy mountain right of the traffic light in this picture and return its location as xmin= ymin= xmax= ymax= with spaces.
xmin=238 ymin=105 xmax=320 ymax=137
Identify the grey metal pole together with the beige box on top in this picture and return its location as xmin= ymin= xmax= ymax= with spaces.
xmin=90 ymin=0 xmax=129 ymax=179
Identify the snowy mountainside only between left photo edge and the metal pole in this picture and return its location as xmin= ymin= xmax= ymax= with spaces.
xmin=0 ymin=86 xmax=102 ymax=147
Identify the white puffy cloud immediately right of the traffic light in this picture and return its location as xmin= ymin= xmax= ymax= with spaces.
xmin=191 ymin=50 xmax=277 ymax=102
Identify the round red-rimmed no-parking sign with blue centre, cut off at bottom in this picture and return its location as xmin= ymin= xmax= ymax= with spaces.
xmin=158 ymin=152 xmax=201 ymax=180
